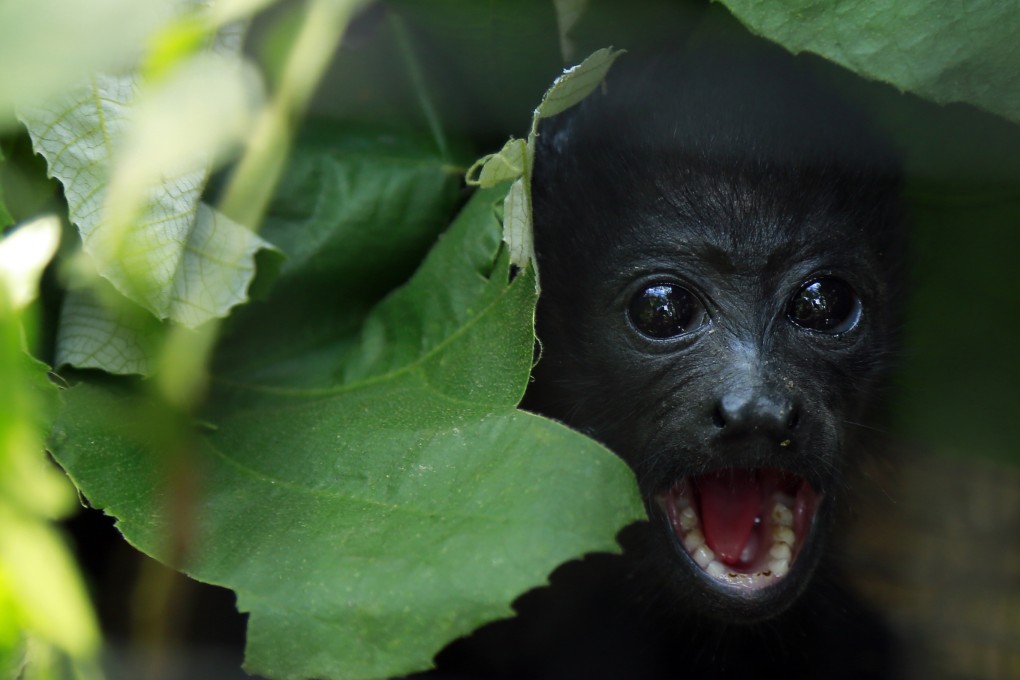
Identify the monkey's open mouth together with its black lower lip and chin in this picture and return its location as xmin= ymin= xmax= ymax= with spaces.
xmin=654 ymin=468 xmax=827 ymax=621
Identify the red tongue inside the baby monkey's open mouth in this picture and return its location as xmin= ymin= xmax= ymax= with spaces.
xmin=697 ymin=470 xmax=762 ymax=565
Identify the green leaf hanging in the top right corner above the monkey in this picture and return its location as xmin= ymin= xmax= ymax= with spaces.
xmin=722 ymin=0 xmax=1020 ymax=121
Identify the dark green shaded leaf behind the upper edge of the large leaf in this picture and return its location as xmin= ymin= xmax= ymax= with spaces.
xmin=215 ymin=124 xmax=462 ymax=385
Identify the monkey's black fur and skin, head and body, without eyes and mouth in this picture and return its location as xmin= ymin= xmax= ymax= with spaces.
xmin=426 ymin=43 xmax=904 ymax=679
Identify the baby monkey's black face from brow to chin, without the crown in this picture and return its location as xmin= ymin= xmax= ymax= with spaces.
xmin=536 ymin=177 xmax=891 ymax=621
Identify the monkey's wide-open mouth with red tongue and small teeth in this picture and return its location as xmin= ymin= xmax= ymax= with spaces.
xmin=656 ymin=469 xmax=820 ymax=589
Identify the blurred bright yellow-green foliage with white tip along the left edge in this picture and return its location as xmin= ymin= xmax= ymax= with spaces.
xmin=0 ymin=231 xmax=99 ymax=673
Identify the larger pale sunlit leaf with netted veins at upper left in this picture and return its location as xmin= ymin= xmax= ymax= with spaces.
xmin=22 ymin=67 xmax=270 ymax=327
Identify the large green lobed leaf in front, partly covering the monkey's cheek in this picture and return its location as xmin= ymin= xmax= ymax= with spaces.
xmin=53 ymin=186 xmax=643 ymax=678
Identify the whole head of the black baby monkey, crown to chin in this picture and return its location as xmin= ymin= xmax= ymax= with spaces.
xmin=528 ymin=47 xmax=903 ymax=621
